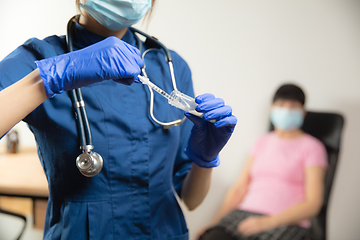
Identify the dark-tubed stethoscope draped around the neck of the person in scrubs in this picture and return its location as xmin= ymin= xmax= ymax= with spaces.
xmin=66 ymin=15 xmax=186 ymax=177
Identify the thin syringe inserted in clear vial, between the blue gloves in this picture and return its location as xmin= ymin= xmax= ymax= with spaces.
xmin=138 ymin=75 xmax=204 ymax=117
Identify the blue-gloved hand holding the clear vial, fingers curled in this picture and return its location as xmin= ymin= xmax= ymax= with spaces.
xmin=185 ymin=93 xmax=237 ymax=168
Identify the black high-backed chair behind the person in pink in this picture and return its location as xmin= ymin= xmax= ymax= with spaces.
xmin=270 ymin=112 xmax=344 ymax=240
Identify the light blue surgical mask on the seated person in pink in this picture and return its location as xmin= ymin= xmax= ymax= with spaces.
xmin=270 ymin=107 xmax=304 ymax=131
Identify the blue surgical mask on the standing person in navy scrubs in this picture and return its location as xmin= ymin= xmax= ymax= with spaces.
xmin=80 ymin=0 xmax=151 ymax=31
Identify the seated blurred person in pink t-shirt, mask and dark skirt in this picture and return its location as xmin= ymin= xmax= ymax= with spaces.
xmin=199 ymin=84 xmax=327 ymax=240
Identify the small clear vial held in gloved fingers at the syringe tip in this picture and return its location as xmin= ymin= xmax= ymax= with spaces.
xmin=168 ymin=90 xmax=204 ymax=117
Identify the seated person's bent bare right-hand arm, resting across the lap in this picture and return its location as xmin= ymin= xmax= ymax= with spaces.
xmin=238 ymin=166 xmax=325 ymax=235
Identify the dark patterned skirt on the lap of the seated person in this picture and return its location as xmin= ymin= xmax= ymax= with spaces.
xmin=199 ymin=210 xmax=310 ymax=240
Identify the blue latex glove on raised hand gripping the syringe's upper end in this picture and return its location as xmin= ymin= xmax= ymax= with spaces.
xmin=35 ymin=37 xmax=144 ymax=98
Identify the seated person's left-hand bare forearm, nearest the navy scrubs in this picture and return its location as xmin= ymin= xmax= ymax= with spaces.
xmin=211 ymin=156 xmax=254 ymax=225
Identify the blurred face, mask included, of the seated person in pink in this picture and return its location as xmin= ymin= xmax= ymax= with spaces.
xmin=270 ymin=100 xmax=304 ymax=131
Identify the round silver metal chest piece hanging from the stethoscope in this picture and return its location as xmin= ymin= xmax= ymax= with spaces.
xmin=76 ymin=151 xmax=103 ymax=177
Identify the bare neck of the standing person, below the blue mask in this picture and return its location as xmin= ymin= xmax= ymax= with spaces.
xmin=79 ymin=11 xmax=127 ymax=39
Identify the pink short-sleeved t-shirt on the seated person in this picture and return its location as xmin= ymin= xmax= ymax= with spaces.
xmin=238 ymin=132 xmax=327 ymax=227
